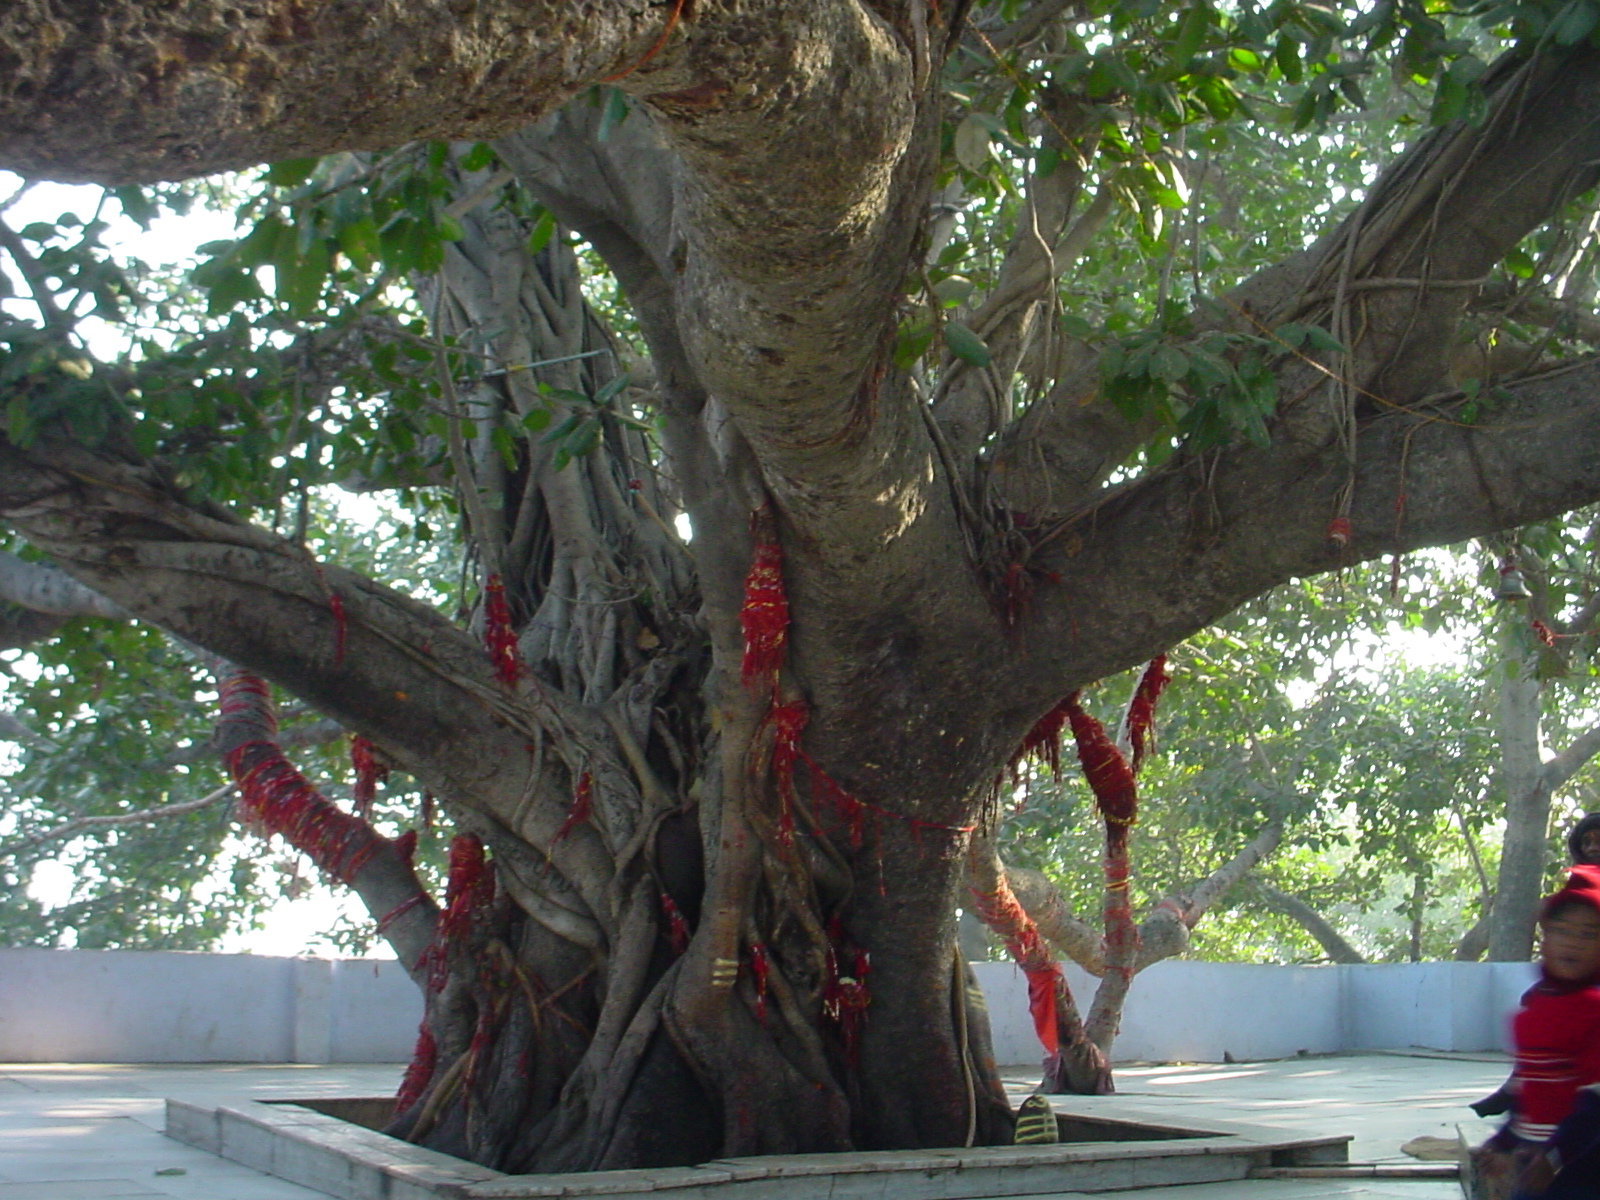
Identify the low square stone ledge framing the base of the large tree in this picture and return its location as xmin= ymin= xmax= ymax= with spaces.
xmin=166 ymin=1096 xmax=1350 ymax=1200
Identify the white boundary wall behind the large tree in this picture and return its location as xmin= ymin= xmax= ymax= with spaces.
xmin=0 ymin=949 xmax=1534 ymax=1062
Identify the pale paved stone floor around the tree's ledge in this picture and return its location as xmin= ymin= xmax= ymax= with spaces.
xmin=0 ymin=1054 xmax=1506 ymax=1200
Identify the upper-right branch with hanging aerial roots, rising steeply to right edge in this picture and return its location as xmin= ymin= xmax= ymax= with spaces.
xmin=997 ymin=50 xmax=1600 ymax=525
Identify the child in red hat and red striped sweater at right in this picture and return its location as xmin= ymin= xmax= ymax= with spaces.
xmin=1494 ymin=864 xmax=1600 ymax=1200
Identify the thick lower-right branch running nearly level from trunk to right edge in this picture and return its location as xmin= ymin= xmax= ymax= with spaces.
xmin=1019 ymin=362 xmax=1600 ymax=710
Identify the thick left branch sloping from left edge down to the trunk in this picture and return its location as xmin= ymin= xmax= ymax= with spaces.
xmin=0 ymin=443 xmax=544 ymax=825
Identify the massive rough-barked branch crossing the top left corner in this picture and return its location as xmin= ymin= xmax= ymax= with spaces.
xmin=0 ymin=0 xmax=684 ymax=184
